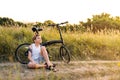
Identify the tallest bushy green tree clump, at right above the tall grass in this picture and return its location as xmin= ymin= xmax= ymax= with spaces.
xmin=80 ymin=13 xmax=120 ymax=33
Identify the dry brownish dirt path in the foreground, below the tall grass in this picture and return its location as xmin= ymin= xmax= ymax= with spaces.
xmin=0 ymin=61 xmax=120 ymax=80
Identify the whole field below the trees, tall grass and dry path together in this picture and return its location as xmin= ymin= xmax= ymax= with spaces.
xmin=0 ymin=27 xmax=120 ymax=80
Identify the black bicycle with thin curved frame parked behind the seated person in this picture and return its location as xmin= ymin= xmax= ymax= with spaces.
xmin=15 ymin=22 xmax=70 ymax=64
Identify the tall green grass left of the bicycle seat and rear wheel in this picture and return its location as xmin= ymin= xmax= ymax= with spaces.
xmin=0 ymin=27 xmax=32 ymax=62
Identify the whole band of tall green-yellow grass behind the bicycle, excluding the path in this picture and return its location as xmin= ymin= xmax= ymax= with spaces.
xmin=0 ymin=27 xmax=120 ymax=61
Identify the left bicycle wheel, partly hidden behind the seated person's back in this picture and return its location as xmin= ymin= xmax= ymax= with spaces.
xmin=15 ymin=43 xmax=30 ymax=64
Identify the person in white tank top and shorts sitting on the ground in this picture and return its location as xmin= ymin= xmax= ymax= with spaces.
xmin=28 ymin=34 xmax=56 ymax=71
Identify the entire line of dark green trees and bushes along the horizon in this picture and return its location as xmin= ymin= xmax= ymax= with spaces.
xmin=0 ymin=13 xmax=120 ymax=33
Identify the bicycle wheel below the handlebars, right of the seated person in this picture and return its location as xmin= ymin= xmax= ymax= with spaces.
xmin=60 ymin=46 xmax=70 ymax=63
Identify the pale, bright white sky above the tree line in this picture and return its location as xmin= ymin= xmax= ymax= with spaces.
xmin=0 ymin=0 xmax=120 ymax=23
